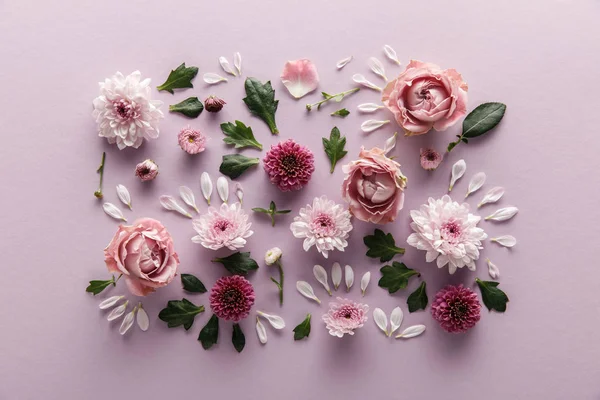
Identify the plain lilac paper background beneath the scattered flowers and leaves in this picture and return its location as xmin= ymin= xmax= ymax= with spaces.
xmin=0 ymin=0 xmax=600 ymax=400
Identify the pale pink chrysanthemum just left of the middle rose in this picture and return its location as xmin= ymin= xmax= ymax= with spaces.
xmin=290 ymin=196 xmax=352 ymax=258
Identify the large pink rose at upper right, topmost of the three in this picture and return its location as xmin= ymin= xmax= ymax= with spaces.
xmin=381 ymin=60 xmax=469 ymax=136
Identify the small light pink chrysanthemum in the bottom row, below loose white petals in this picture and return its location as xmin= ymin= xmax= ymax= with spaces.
xmin=323 ymin=297 xmax=369 ymax=337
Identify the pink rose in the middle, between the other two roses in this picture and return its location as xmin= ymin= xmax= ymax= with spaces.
xmin=342 ymin=147 xmax=406 ymax=224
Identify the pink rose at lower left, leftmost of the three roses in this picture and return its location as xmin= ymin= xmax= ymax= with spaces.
xmin=104 ymin=218 xmax=179 ymax=296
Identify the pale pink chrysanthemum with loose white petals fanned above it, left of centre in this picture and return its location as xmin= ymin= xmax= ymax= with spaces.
xmin=192 ymin=203 xmax=254 ymax=250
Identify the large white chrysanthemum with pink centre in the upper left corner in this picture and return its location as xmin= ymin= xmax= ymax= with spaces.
xmin=92 ymin=71 xmax=164 ymax=150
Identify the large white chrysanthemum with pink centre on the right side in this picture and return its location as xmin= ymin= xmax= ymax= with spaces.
xmin=407 ymin=195 xmax=487 ymax=274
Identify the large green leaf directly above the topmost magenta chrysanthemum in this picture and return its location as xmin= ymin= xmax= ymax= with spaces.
xmin=243 ymin=78 xmax=279 ymax=135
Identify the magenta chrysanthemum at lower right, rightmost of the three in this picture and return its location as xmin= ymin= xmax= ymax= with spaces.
xmin=431 ymin=285 xmax=481 ymax=333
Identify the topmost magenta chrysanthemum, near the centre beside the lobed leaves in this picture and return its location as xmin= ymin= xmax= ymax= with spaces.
xmin=263 ymin=139 xmax=315 ymax=192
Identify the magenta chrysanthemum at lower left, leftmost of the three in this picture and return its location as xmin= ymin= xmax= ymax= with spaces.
xmin=209 ymin=275 xmax=254 ymax=322
